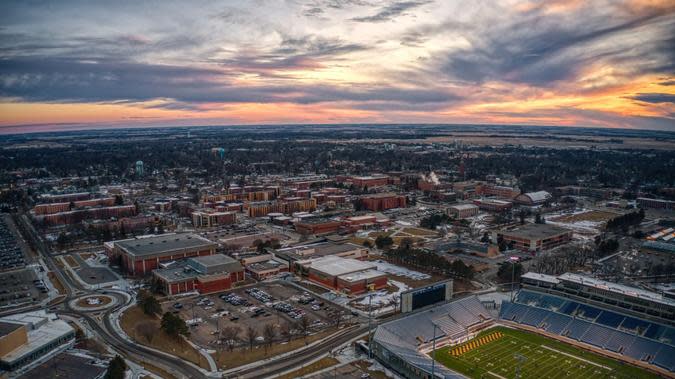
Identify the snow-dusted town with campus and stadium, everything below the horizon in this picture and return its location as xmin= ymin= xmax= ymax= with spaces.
xmin=0 ymin=127 xmax=675 ymax=379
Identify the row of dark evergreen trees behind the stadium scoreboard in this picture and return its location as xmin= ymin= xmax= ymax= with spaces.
xmin=385 ymin=238 xmax=474 ymax=280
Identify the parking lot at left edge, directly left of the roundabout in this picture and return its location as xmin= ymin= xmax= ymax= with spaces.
xmin=0 ymin=268 xmax=49 ymax=307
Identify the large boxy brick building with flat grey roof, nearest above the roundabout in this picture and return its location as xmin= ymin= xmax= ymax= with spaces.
xmin=104 ymin=233 xmax=218 ymax=275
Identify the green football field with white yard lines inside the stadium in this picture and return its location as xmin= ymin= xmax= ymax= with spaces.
xmin=430 ymin=327 xmax=659 ymax=379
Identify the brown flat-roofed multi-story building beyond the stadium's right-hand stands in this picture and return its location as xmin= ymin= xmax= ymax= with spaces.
xmin=492 ymin=224 xmax=572 ymax=252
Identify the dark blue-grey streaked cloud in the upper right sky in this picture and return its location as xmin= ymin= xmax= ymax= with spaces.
xmin=438 ymin=5 xmax=675 ymax=86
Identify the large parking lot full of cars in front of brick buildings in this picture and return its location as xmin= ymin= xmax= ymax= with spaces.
xmin=163 ymin=282 xmax=352 ymax=348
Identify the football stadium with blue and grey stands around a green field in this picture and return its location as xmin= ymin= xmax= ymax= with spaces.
xmin=371 ymin=273 xmax=675 ymax=379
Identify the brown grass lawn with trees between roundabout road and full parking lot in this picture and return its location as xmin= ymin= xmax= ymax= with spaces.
xmin=120 ymin=306 xmax=209 ymax=369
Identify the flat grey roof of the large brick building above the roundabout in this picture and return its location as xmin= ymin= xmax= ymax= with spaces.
xmin=115 ymin=233 xmax=216 ymax=257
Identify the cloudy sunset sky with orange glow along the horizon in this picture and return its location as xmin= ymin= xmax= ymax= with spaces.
xmin=0 ymin=0 xmax=675 ymax=133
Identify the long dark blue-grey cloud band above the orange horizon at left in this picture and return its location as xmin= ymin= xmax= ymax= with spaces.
xmin=0 ymin=57 xmax=457 ymax=110
